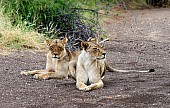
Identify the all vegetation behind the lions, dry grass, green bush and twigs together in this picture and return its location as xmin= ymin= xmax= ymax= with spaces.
xmin=0 ymin=0 xmax=168 ymax=49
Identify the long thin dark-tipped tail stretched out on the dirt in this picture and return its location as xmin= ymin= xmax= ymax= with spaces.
xmin=106 ymin=65 xmax=155 ymax=73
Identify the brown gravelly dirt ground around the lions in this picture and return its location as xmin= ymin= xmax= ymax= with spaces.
xmin=0 ymin=8 xmax=170 ymax=108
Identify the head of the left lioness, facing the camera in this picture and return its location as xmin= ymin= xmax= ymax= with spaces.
xmin=46 ymin=37 xmax=67 ymax=59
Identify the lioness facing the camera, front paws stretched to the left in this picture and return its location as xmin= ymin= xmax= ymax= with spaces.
xmin=20 ymin=37 xmax=72 ymax=79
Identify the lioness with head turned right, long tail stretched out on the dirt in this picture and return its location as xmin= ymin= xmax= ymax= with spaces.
xmin=69 ymin=39 xmax=154 ymax=91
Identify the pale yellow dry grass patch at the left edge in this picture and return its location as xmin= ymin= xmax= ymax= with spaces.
xmin=0 ymin=8 xmax=43 ymax=49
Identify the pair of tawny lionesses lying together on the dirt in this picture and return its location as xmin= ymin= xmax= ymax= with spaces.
xmin=21 ymin=37 xmax=154 ymax=91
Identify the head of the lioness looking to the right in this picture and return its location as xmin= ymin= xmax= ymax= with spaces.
xmin=81 ymin=38 xmax=106 ymax=60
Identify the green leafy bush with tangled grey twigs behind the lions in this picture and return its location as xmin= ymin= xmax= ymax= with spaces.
xmin=1 ymin=0 xmax=106 ymax=49
